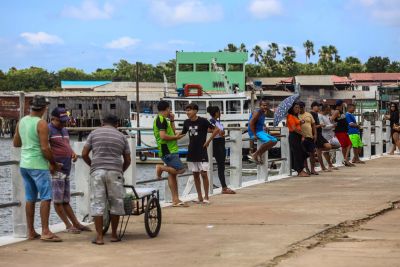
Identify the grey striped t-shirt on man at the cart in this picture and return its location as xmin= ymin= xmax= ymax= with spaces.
xmin=85 ymin=126 xmax=130 ymax=173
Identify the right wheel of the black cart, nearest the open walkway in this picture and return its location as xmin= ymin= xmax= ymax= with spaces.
xmin=144 ymin=197 xmax=161 ymax=237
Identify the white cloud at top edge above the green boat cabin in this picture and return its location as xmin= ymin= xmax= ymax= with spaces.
xmin=150 ymin=0 xmax=223 ymax=25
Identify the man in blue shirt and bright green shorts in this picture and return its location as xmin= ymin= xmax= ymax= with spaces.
xmin=346 ymin=104 xmax=365 ymax=163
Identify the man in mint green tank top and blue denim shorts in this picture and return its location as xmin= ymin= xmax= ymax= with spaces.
xmin=13 ymin=95 xmax=62 ymax=242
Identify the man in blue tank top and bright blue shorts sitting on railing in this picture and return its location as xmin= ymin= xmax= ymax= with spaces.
xmin=248 ymin=98 xmax=278 ymax=164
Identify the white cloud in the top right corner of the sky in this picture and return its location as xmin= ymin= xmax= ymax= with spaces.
xmin=353 ymin=0 xmax=400 ymax=26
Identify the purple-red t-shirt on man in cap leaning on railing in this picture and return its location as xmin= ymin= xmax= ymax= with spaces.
xmin=48 ymin=123 xmax=72 ymax=175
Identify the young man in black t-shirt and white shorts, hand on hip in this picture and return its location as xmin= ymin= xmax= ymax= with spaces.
xmin=182 ymin=103 xmax=220 ymax=203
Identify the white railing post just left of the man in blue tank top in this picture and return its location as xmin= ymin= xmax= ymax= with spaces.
xmin=229 ymin=130 xmax=243 ymax=188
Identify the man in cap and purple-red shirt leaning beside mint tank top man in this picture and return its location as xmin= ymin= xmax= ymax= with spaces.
xmin=49 ymin=107 xmax=90 ymax=234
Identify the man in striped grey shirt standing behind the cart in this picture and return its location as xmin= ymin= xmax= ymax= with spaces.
xmin=82 ymin=115 xmax=131 ymax=245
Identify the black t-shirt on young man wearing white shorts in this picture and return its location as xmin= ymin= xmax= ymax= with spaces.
xmin=182 ymin=117 xmax=213 ymax=162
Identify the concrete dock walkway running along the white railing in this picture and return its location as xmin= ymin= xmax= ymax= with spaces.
xmin=0 ymin=156 xmax=400 ymax=267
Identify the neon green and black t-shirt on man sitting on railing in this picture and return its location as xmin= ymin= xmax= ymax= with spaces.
xmin=153 ymin=114 xmax=179 ymax=158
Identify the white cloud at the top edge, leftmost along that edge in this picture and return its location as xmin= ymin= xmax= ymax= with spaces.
xmin=61 ymin=0 xmax=114 ymax=20
